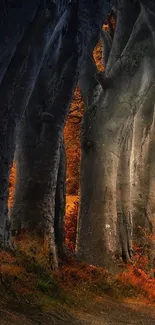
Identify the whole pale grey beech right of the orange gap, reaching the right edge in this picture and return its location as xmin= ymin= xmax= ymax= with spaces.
xmin=76 ymin=0 xmax=155 ymax=269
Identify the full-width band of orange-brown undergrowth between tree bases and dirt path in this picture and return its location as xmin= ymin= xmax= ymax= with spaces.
xmin=0 ymin=223 xmax=155 ymax=310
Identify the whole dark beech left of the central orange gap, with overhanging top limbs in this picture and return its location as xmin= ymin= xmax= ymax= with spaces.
xmin=6 ymin=0 xmax=114 ymax=266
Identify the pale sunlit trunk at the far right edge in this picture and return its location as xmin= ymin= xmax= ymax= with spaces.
xmin=131 ymin=103 xmax=154 ymax=238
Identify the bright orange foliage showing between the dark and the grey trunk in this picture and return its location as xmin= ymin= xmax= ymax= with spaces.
xmin=64 ymin=41 xmax=104 ymax=247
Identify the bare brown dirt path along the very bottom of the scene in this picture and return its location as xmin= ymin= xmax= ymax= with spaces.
xmin=0 ymin=299 xmax=155 ymax=325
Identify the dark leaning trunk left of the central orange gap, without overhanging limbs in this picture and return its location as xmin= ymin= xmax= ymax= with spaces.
xmin=11 ymin=1 xmax=79 ymax=267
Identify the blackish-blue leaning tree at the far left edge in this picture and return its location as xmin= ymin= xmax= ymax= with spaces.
xmin=0 ymin=1 xmax=61 ymax=245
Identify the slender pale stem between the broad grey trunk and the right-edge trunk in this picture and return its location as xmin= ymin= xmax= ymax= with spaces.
xmin=117 ymin=127 xmax=133 ymax=262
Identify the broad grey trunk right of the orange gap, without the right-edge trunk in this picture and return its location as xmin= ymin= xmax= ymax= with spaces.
xmin=76 ymin=1 xmax=155 ymax=270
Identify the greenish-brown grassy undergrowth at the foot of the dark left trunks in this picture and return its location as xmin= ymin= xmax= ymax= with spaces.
xmin=0 ymin=237 xmax=71 ymax=308
